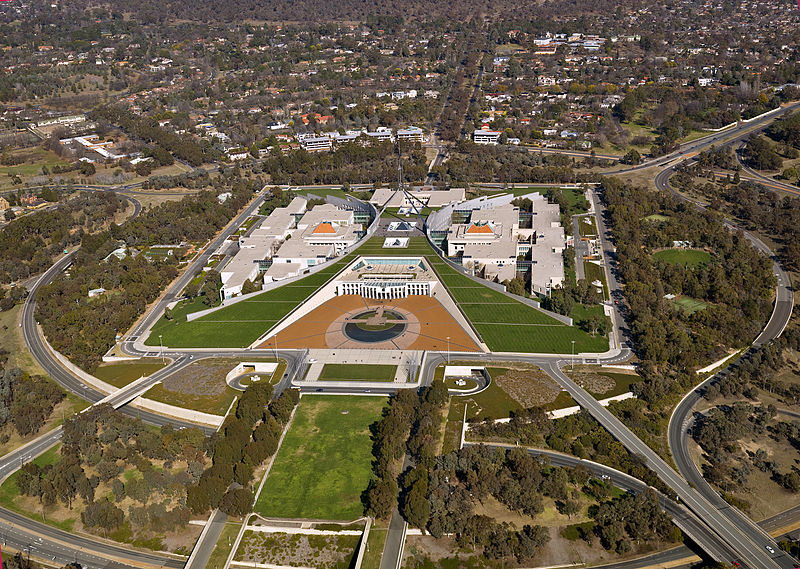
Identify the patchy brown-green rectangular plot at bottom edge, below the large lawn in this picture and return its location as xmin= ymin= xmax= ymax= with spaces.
xmin=236 ymin=531 xmax=361 ymax=569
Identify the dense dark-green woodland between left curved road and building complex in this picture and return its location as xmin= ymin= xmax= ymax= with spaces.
xmin=36 ymin=174 xmax=260 ymax=372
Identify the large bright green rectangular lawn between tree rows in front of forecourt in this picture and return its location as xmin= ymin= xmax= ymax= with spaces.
xmin=255 ymin=395 xmax=386 ymax=520
